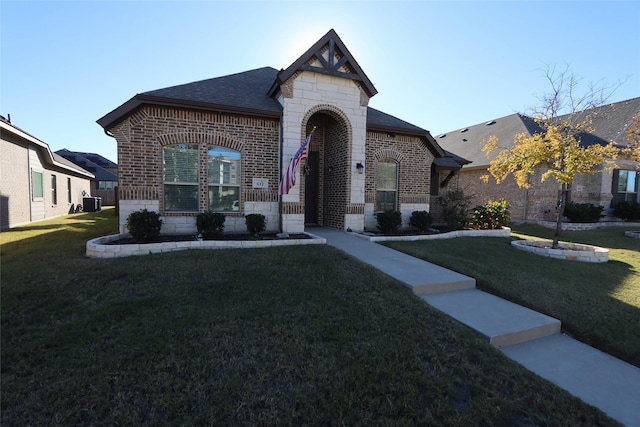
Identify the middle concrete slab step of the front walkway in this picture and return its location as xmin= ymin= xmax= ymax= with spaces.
xmin=421 ymin=289 xmax=560 ymax=348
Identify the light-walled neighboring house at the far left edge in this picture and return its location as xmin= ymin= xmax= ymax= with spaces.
xmin=0 ymin=113 xmax=94 ymax=229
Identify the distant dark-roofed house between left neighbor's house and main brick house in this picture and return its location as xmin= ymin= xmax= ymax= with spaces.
xmin=56 ymin=148 xmax=118 ymax=206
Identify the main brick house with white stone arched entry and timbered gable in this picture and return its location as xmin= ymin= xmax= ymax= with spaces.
xmin=98 ymin=30 xmax=460 ymax=234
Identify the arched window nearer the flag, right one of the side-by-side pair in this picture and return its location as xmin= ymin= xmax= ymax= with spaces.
xmin=207 ymin=145 xmax=242 ymax=212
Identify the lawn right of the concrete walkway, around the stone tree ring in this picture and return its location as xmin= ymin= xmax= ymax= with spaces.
xmin=388 ymin=225 xmax=640 ymax=366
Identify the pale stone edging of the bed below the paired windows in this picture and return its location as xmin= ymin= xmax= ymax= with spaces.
xmin=85 ymin=232 xmax=327 ymax=258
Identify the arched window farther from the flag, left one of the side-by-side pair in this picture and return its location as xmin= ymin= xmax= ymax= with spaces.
xmin=162 ymin=144 xmax=199 ymax=212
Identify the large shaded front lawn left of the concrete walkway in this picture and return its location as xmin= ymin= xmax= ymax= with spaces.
xmin=0 ymin=209 xmax=616 ymax=426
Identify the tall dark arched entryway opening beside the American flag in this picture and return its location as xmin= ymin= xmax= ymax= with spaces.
xmin=301 ymin=106 xmax=352 ymax=229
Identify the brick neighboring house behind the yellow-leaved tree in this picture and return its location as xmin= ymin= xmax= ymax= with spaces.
xmin=436 ymin=98 xmax=640 ymax=221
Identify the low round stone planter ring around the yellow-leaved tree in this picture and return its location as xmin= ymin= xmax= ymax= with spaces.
xmin=511 ymin=240 xmax=609 ymax=263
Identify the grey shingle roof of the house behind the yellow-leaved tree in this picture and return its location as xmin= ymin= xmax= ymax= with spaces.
xmin=435 ymin=98 xmax=640 ymax=168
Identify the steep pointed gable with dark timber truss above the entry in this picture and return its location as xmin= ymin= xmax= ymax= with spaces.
xmin=269 ymin=29 xmax=378 ymax=98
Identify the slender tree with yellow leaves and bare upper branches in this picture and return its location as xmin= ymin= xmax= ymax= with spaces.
xmin=483 ymin=67 xmax=619 ymax=248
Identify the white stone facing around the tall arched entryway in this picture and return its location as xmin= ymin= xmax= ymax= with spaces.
xmin=279 ymin=71 xmax=368 ymax=233
